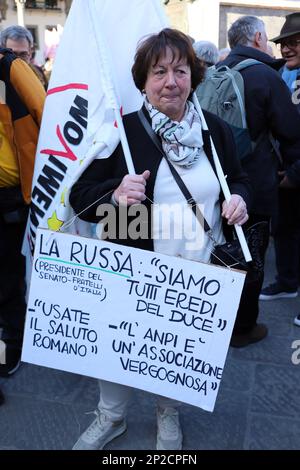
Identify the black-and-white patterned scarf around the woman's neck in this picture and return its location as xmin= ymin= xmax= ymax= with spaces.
xmin=145 ymin=96 xmax=203 ymax=168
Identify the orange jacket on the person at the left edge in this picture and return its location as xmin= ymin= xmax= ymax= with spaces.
xmin=0 ymin=49 xmax=46 ymax=204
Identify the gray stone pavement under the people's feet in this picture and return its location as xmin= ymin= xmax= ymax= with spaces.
xmin=0 ymin=241 xmax=300 ymax=450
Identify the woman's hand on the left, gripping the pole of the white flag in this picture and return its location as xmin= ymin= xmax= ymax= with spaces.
xmin=113 ymin=170 xmax=150 ymax=206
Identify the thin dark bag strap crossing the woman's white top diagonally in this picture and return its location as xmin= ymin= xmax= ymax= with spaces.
xmin=138 ymin=108 xmax=212 ymax=236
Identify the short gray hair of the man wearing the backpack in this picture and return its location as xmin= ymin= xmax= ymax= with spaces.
xmin=228 ymin=16 xmax=265 ymax=49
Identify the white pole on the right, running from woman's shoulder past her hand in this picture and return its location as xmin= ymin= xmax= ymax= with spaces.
xmin=193 ymin=93 xmax=252 ymax=262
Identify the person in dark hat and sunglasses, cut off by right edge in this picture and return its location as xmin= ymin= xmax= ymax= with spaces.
xmin=260 ymin=12 xmax=300 ymax=326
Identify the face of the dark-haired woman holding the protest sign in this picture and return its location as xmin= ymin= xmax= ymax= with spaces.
xmin=145 ymin=47 xmax=191 ymax=121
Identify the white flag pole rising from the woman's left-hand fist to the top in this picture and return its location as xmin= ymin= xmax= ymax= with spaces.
xmin=88 ymin=0 xmax=135 ymax=175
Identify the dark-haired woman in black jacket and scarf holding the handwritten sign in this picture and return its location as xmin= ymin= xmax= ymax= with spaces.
xmin=70 ymin=29 xmax=250 ymax=450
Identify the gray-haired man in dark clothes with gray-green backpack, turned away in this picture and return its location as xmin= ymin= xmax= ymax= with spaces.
xmin=199 ymin=16 xmax=300 ymax=347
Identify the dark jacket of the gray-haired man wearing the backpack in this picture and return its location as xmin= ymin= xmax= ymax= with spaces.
xmin=218 ymin=46 xmax=300 ymax=215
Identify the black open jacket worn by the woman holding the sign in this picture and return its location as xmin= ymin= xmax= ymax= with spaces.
xmin=70 ymin=107 xmax=251 ymax=250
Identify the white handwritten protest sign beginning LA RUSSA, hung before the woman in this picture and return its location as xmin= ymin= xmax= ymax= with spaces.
xmin=22 ymin=229 xmax=245 ymax=411
